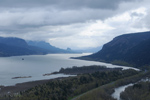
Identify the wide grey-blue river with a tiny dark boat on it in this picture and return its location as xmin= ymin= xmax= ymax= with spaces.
xmin=0 ymin=54 xmax=137 ymax=86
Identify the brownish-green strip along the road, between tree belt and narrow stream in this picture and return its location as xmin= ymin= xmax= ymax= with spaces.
xmin=73 ymin=72 xmax=150 ymax=100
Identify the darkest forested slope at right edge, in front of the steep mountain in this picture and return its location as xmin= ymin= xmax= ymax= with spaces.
xmin=125 ymin=39 xmax=150 ymax=66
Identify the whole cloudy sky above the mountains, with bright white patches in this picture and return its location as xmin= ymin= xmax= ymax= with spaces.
xmin=0 ymin=0 xmax=150 ymax=49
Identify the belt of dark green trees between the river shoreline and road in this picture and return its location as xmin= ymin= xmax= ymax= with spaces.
xmin=0 ymin=69 xmax=139 ymax=100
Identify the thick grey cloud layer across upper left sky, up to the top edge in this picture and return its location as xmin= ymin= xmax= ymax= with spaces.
xmin=0 ymin=0 xmax=141 ymax=27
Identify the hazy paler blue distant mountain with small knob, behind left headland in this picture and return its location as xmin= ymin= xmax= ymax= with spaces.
xmin=27 ymin=41 xmax=77 ymax=53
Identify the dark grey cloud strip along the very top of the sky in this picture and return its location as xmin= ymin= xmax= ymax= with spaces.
xmin=0 ymin=0 xmax=136 ymax=9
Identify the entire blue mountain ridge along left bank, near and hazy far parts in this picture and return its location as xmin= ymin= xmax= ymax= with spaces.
xmin=0 ymin=37 xmax=78 ymax=57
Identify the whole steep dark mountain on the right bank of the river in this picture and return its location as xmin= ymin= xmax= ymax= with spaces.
xmin=80 ymin=32 xmax=150 ymax=67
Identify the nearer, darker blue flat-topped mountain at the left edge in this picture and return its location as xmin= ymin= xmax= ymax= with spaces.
xmin=0 ymin=37 xmax=47 ymax=57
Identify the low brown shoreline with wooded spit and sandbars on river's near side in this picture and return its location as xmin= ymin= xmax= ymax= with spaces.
xmin=0 ymin=65 xmax=122 ymax=96
